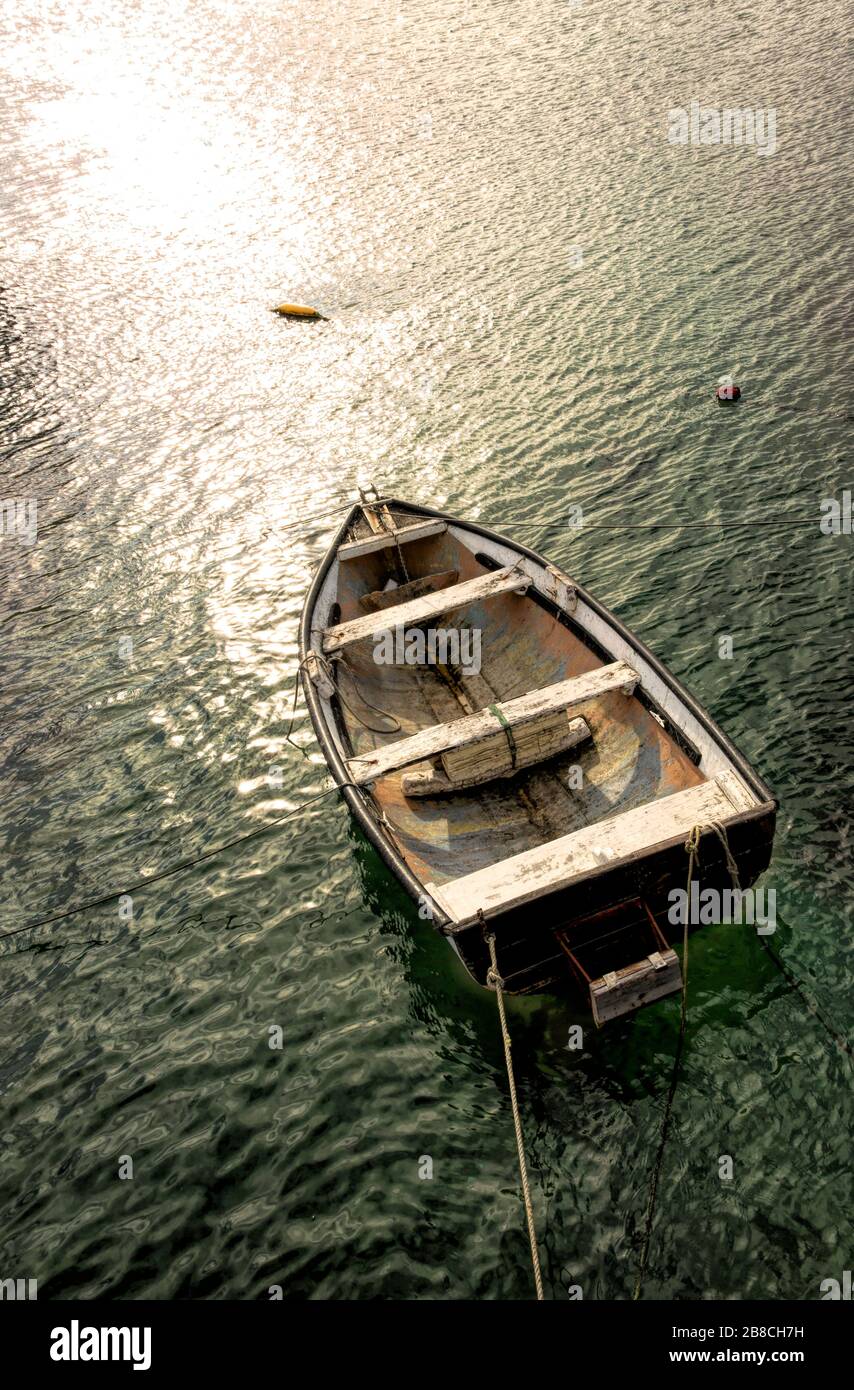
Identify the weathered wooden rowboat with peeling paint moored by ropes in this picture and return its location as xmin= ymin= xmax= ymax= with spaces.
xmin=300 ymin=491 xmax=776 ymax=1023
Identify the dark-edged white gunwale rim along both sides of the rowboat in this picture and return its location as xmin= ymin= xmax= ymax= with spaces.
xmin=299 ymin=496 xmax=779 ymax=934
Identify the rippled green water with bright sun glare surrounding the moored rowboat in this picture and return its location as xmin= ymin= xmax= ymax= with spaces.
xmin=0 ymin=0 xmax=854 ymax=1298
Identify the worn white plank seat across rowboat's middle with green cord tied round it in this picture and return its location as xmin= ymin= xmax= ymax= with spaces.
xmin=348 ymin=658 xmax=637 ymax=784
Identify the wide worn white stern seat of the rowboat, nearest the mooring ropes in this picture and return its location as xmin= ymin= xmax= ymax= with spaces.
xmin=426 ymin=771 xmax=755 ymax=926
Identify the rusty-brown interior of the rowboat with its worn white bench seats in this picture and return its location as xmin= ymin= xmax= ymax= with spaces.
xmin=312 ymin=499 xmax=759 ymax=922
